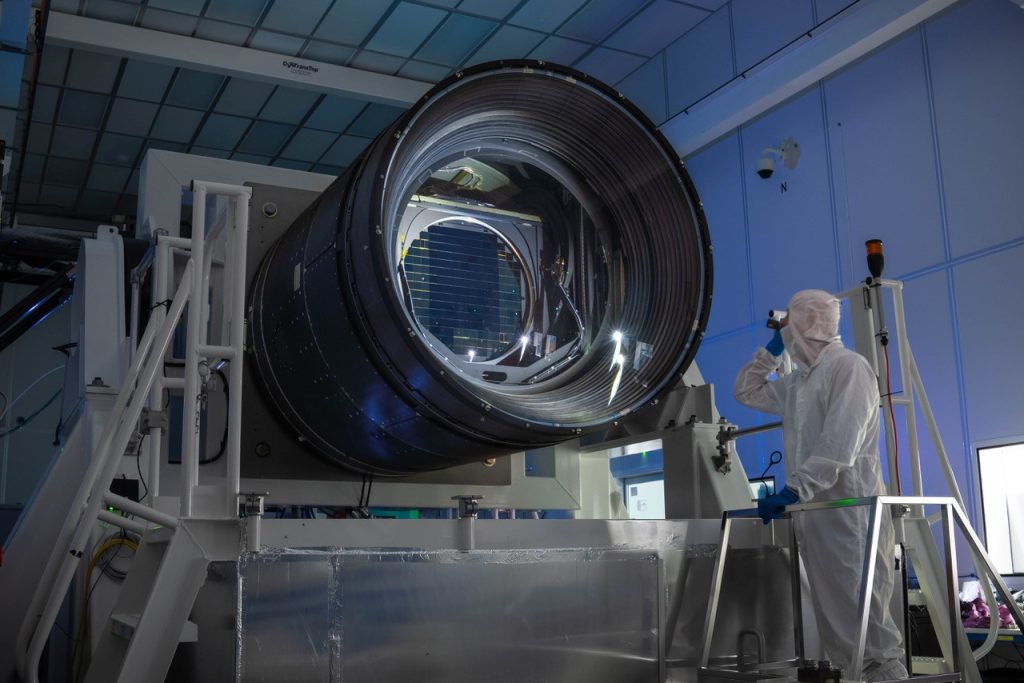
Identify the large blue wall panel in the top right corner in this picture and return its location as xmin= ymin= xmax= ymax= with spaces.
xmin=926 ymin=0 xmax=1024 ymax=257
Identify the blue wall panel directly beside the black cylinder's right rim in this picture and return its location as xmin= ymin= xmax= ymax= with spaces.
xmin=686 ymin=134 xmax=751 ymax=337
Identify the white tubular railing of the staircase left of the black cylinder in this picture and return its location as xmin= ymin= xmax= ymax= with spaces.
xmin=15 ymin=180 xmax=252 ymax=683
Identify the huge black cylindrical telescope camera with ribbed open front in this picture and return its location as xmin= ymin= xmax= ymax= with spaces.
xmin=250 ymin=61 xmax=712 ymax=475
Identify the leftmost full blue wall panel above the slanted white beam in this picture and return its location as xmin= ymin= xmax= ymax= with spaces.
xmin=666 ymin=7 xmax=733 ymax=116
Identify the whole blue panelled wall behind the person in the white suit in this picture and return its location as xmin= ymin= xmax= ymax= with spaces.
xmin=663 ymin=0 xmax=1024 ymax=522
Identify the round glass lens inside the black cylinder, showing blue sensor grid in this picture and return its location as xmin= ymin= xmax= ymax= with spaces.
xmin=394 ymin=155 xmax=608 ymax=385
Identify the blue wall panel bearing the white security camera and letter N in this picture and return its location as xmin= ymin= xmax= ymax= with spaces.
xmin=745 ymin=89 xmax=839 ymax=319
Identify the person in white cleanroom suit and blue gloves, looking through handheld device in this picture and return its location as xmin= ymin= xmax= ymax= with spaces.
xmin=733 ymin=290 xmax=907 ymax=681
